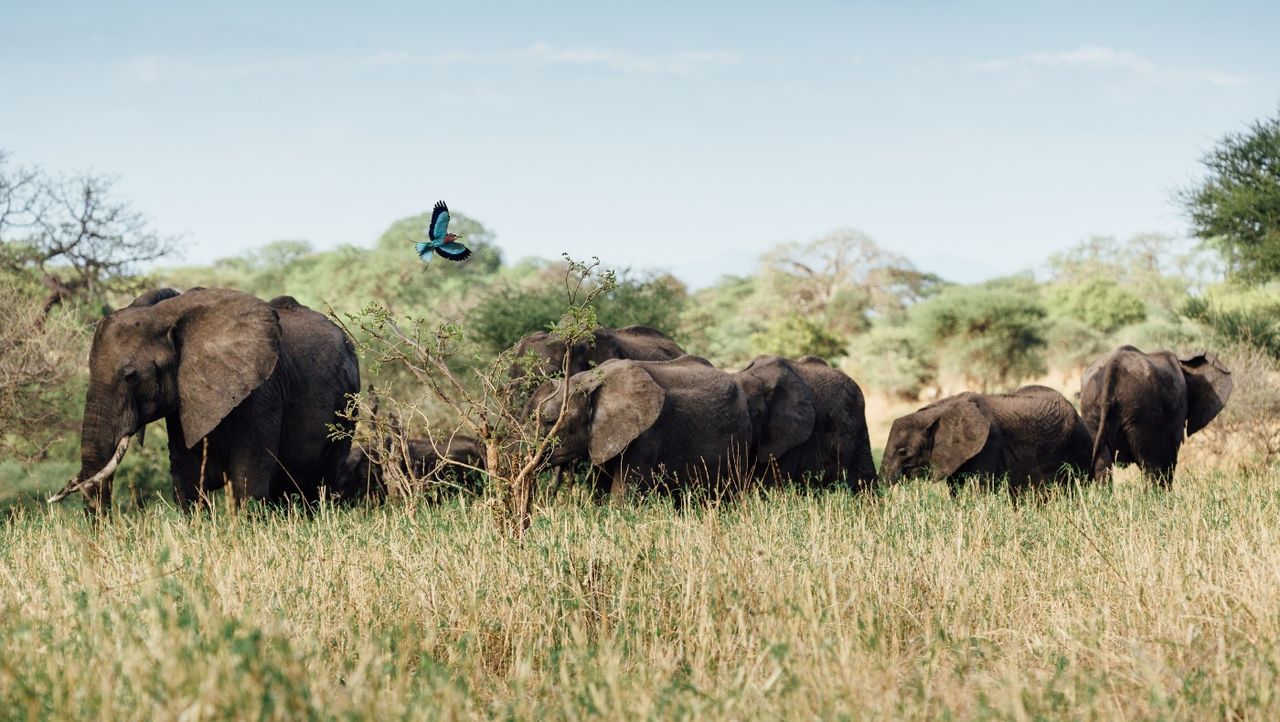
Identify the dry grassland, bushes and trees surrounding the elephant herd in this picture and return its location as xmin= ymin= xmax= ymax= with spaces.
xmin=0 ymin=106 xmax=1280 ymax=719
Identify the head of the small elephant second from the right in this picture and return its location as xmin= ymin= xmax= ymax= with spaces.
xmin=881 ymin=396 xmax=991 ymax=481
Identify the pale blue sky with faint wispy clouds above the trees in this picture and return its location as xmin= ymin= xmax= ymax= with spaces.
xmin=0 ymin=0 xmax=1280 ymax=285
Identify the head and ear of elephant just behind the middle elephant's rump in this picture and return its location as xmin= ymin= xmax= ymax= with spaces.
xmin=733 ymin=356 xmax=817 ymax=462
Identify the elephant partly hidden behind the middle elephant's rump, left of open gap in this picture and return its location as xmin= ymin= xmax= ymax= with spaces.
xmin=733 ymin=356 xmax=876 ymax=490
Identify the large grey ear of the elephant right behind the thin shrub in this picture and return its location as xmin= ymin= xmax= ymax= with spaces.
xmin=588 ymin=361 xmax=667 ymax=465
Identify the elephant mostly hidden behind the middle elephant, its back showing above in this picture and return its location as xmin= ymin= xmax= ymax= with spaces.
xmin=511 ymin=325 xmax=685 ymax=379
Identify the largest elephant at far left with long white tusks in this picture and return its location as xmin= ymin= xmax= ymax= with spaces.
xmin=61 ymin=288 xmax=360 ymax=511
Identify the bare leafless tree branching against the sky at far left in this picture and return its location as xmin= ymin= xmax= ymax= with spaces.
xmin=0 ymin=151 xmax=178 ymax=314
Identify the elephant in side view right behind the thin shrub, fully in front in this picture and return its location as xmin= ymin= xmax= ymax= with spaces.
xmin=534 ymin=356 xmax=751 ymax=501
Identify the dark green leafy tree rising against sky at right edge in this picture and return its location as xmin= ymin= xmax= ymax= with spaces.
xmin=1179 ymin=113 xmax=1280 ymax=282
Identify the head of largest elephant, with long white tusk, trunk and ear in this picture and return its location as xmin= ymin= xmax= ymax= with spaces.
xmin=68 ymin=288 xmax=280 ymax=507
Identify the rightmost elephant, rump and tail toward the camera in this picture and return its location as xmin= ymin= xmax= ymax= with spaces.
xmin=1080 ymin=346 xmax=1231 ymax=486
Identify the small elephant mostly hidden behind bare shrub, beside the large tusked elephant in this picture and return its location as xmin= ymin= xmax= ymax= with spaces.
xmin=344 ymin=434 xmax=485 ymax=495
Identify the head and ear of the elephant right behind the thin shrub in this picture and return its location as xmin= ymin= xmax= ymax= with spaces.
xmin=536 ymin=360 xmax=666 ymax=465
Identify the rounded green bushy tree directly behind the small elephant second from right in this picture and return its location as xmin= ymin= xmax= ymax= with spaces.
xmin=911 ymin=285 xmax=1046 ymax=390
